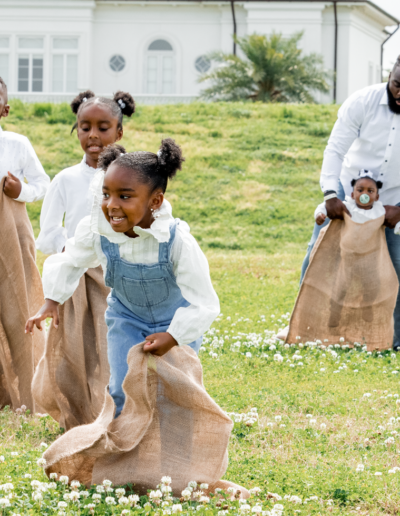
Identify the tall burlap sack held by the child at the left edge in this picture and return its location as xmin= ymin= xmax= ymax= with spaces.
xmin=0 ymin=178 xmax=44 ymax=411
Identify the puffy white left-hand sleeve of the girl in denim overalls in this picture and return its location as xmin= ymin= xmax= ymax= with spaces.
xmin=43 ymin=215 xmax=100 ymax=304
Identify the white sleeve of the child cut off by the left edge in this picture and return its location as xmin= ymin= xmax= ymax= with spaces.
xmin=16 ymin=138 xmax=50 ymax=202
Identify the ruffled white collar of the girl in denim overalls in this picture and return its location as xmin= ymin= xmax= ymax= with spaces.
xmin=90 ymin=170 xmax=174 ymax=244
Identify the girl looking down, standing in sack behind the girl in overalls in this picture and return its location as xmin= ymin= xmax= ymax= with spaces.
xmin=32 ymin=91 xmax=135 ymax=430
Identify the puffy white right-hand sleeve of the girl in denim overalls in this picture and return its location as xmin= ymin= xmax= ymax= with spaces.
xmin=167 ymin=222 xmax=220 ymax=346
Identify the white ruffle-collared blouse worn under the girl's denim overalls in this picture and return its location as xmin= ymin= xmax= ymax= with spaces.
xmin=43 ymin=171 xmax=220 ymax=345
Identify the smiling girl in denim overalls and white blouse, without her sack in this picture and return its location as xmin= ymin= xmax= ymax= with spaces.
xmin=26 ymin=139 xmax=219 ymax=417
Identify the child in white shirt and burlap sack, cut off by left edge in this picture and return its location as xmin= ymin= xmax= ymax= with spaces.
xmin=0 ymin=78 xmax=50 ymax=411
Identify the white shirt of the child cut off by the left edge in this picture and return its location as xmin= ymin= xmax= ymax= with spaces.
xmin=0 ymin=127 xmax=50 ymax=202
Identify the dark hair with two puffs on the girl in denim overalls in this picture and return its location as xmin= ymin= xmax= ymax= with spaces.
xmin=98 ymin=138 xmax=185 ymax=193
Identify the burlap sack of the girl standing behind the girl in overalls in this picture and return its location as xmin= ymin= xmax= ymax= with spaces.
xmin=32 ymin=267 xmax=110 ymax=430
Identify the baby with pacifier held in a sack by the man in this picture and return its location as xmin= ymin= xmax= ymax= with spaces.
xmin=314 ymin=170 xmax=400 ymax=234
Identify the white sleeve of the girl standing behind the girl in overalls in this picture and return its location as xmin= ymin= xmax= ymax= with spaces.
xmin=36 ymin=176 xmax=68 ymax=254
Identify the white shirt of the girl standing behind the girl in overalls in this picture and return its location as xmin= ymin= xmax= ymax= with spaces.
xmin=36 ymin=156 xmax=97 ymax=254
